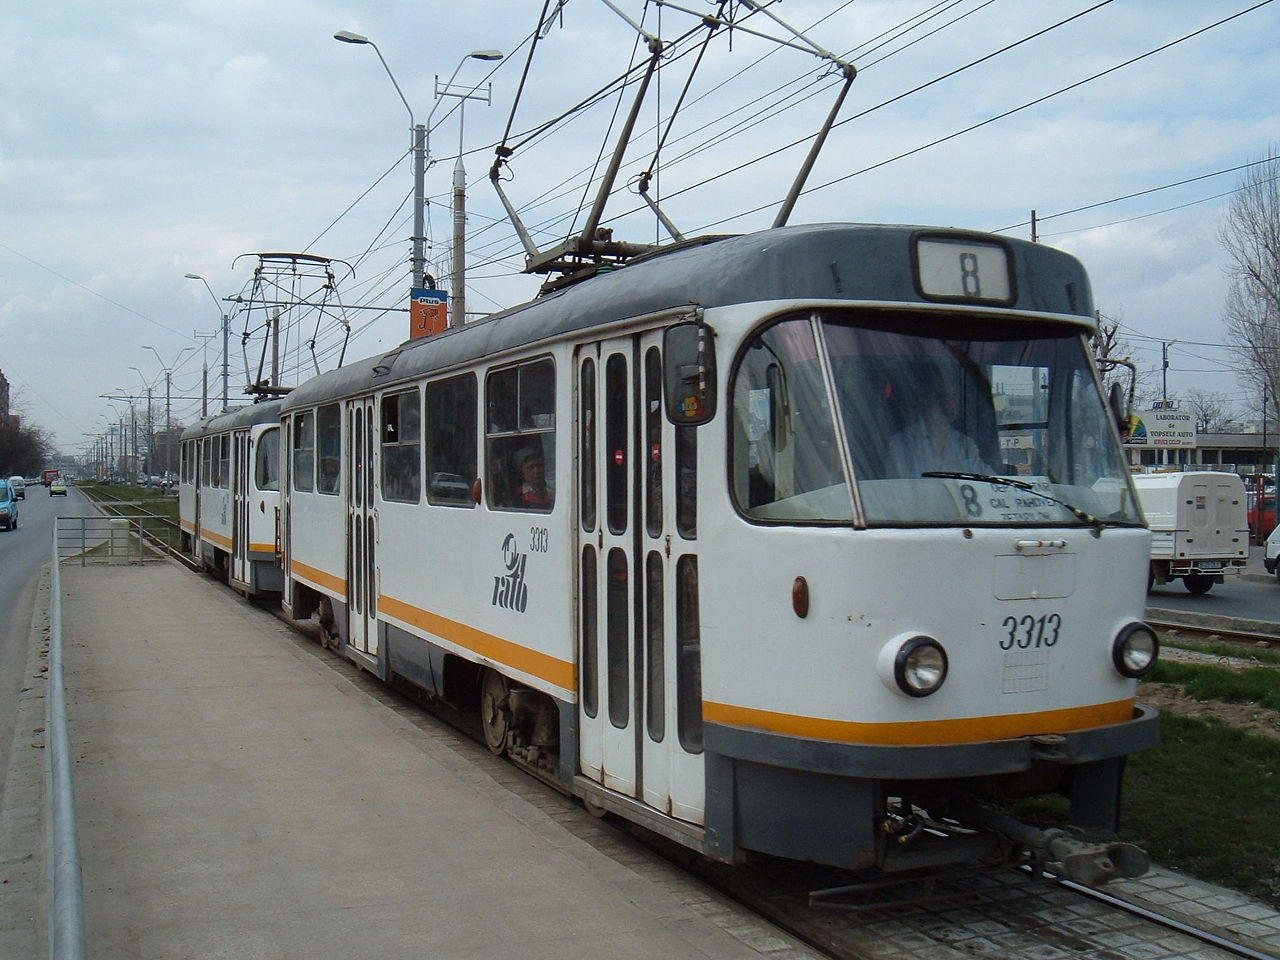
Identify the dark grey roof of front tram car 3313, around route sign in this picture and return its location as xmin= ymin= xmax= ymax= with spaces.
xmin=284 ymin=223 xmax=1093 ymax=410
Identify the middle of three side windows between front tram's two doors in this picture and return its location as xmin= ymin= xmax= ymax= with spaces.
xmin=426 ymin=374 xmax=476 ymax=507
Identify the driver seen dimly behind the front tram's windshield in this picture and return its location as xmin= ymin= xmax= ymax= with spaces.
xmin=888 ymin=364 xmax=997 ymax=477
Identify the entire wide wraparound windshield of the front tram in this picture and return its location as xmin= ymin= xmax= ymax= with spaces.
xmin=731 ymin=310 xmax=1142 ymax=526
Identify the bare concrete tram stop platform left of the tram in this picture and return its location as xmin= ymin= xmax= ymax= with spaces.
xmin=10 ymin=563 xmax=814 ymax=960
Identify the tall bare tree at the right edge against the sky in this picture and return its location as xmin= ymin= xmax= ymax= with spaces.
xmin=1219 ymin=148 xmax=1280 ymax=401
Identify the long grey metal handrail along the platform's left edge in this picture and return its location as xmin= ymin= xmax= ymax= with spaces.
xmin=45 ymin=535 xmax=84 ymax=960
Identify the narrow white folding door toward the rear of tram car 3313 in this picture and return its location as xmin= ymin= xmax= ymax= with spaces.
xmin=347 ymin=397 xmax=378 ymax=657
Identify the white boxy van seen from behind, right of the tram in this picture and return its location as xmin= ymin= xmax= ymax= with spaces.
xmin=1133 ymin=471 xmax=1249 ymax=594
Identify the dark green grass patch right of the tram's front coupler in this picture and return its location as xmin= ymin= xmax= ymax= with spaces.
xmin=1121 ymin=713 xmax=1280 ymax=906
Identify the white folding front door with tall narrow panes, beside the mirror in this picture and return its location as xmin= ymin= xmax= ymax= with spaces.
xmin=576 ymin=332 xmax=705 ymax=823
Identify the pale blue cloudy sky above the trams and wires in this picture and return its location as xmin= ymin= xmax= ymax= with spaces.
xmin=0 ymin=0 xmax=1280 ymax=452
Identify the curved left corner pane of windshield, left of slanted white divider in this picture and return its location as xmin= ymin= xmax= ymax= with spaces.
xmin=730 ymin=317 xmax=852 ymax=521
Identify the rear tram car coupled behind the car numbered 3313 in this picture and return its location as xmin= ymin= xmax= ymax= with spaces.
xmin=178 ymin=399 xmax=284 ymax=596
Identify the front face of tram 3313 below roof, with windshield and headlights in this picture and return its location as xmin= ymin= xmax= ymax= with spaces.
xmin=703 ymin=273 xmax=1157 ymax=868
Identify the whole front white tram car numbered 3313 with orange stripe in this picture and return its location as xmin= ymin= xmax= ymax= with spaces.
xmin=177 ymin=224 xmax=1157 ymax=869
